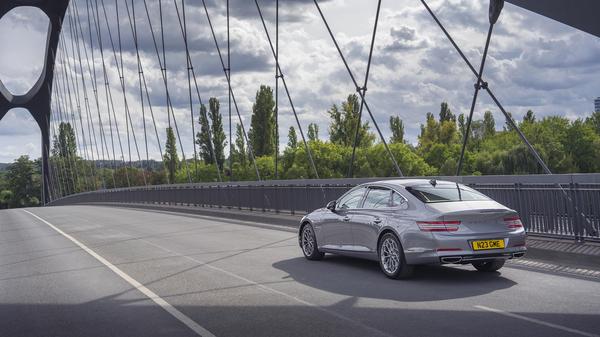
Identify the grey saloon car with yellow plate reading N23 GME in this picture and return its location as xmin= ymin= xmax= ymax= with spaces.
xmin=298 ymin=179 xmax=527 ymax=278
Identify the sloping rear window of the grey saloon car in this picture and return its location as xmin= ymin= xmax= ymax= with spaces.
xmin=406 ymin=184 xmax=490 ymax=203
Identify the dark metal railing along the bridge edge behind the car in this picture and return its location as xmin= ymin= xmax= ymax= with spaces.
xmin=49 ymin=174 xmax=600 ymax=241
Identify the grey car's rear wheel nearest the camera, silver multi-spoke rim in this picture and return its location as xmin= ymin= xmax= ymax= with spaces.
xmin=377 ymin=233 xmax=414 ymax=279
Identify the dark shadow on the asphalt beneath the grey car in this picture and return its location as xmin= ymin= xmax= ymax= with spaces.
xmin=273 ymin=255 xmax=517 ymax=302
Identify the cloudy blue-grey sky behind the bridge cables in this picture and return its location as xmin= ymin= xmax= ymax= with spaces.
xmin=0 ymin=0 xmax=600 ymax=162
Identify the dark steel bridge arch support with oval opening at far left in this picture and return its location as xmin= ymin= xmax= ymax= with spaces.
xmin=0 ymin=0 xmax=69 ymax=204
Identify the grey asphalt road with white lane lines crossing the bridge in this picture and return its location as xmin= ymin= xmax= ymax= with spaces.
xmin=0 ymin=206 xmax=600 ymax=337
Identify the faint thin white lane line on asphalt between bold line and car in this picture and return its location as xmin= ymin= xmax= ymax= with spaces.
xmin=138 ymin=239 xmax=393 ymax=337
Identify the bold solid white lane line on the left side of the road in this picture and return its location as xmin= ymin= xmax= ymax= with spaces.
xmin=23 ymin=210 xmax=215 ymax=337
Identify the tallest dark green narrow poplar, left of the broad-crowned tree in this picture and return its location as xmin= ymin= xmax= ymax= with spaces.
xmin=249 ymin=85 xmax=275 ymax=157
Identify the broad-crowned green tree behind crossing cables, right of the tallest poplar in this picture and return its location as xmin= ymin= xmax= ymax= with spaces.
xmin=327 ymin=94 xmax=375 ymax=147
